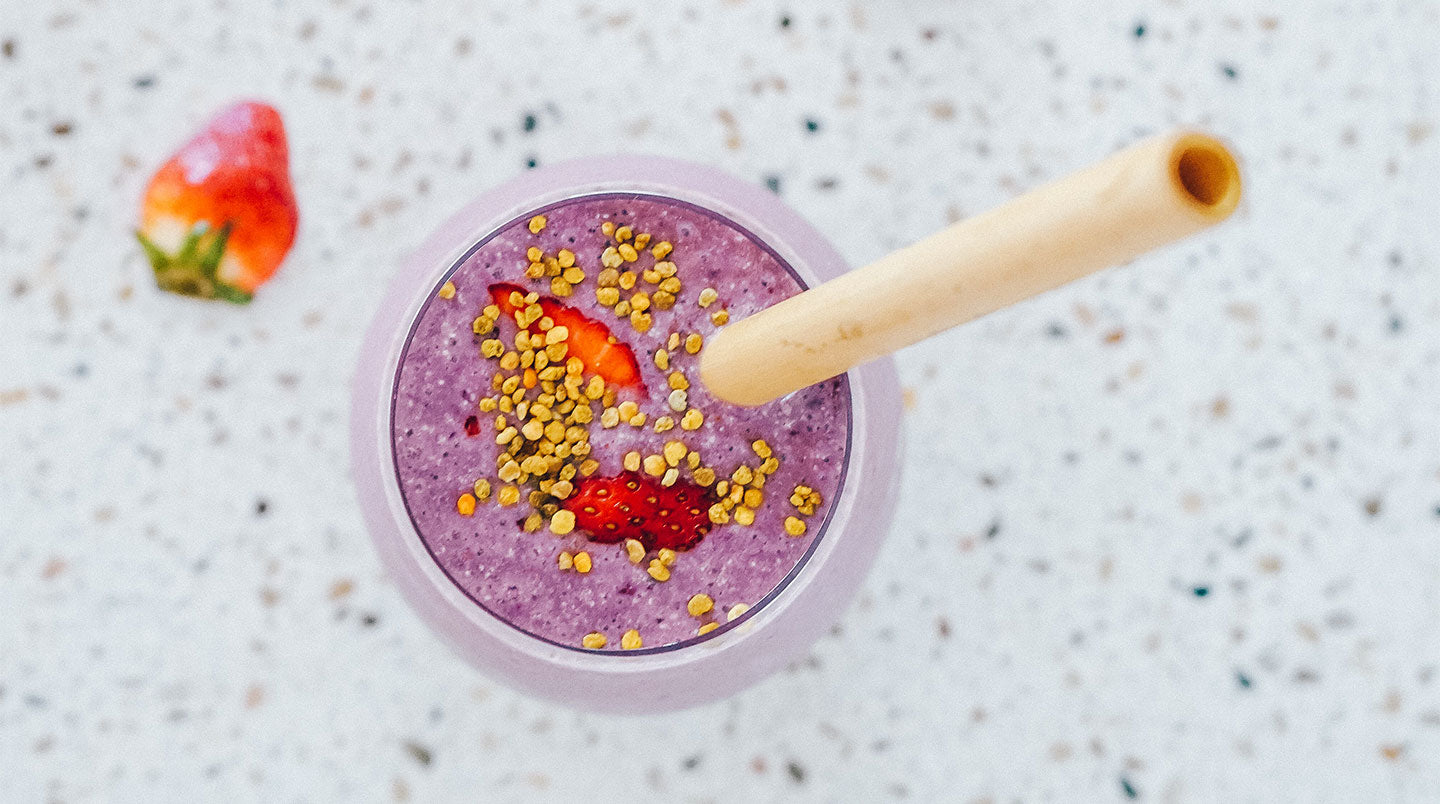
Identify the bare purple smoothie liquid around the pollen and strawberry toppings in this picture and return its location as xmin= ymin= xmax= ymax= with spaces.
xmin=392 ymin=195 xmax=851 ymax=651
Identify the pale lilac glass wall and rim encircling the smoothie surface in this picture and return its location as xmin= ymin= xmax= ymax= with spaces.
xmin=351 ymin=157 xmax=900 ymax=712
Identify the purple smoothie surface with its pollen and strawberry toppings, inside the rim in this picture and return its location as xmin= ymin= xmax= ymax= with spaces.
xmin=392 ymin=195 xmax=851 ymax=651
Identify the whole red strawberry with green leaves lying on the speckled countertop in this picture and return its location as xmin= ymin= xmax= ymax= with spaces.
xmin=135 ymin=101 xmax=300 ymax=304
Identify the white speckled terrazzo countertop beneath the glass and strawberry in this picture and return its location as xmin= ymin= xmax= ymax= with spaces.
xmin=0 ymin=0 xmax=1440 ymax=801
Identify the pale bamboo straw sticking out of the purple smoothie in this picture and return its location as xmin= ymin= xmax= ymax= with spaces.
xmin=700 ymin=131 xmax=1240 ymax=405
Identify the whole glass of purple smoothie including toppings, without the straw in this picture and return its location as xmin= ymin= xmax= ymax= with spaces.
xmin=353 ymin=160 xmax=899 ymax=710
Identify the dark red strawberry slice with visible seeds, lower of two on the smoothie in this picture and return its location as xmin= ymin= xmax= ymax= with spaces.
xmin=562 ymin=471 xmax=711 ymax=550
